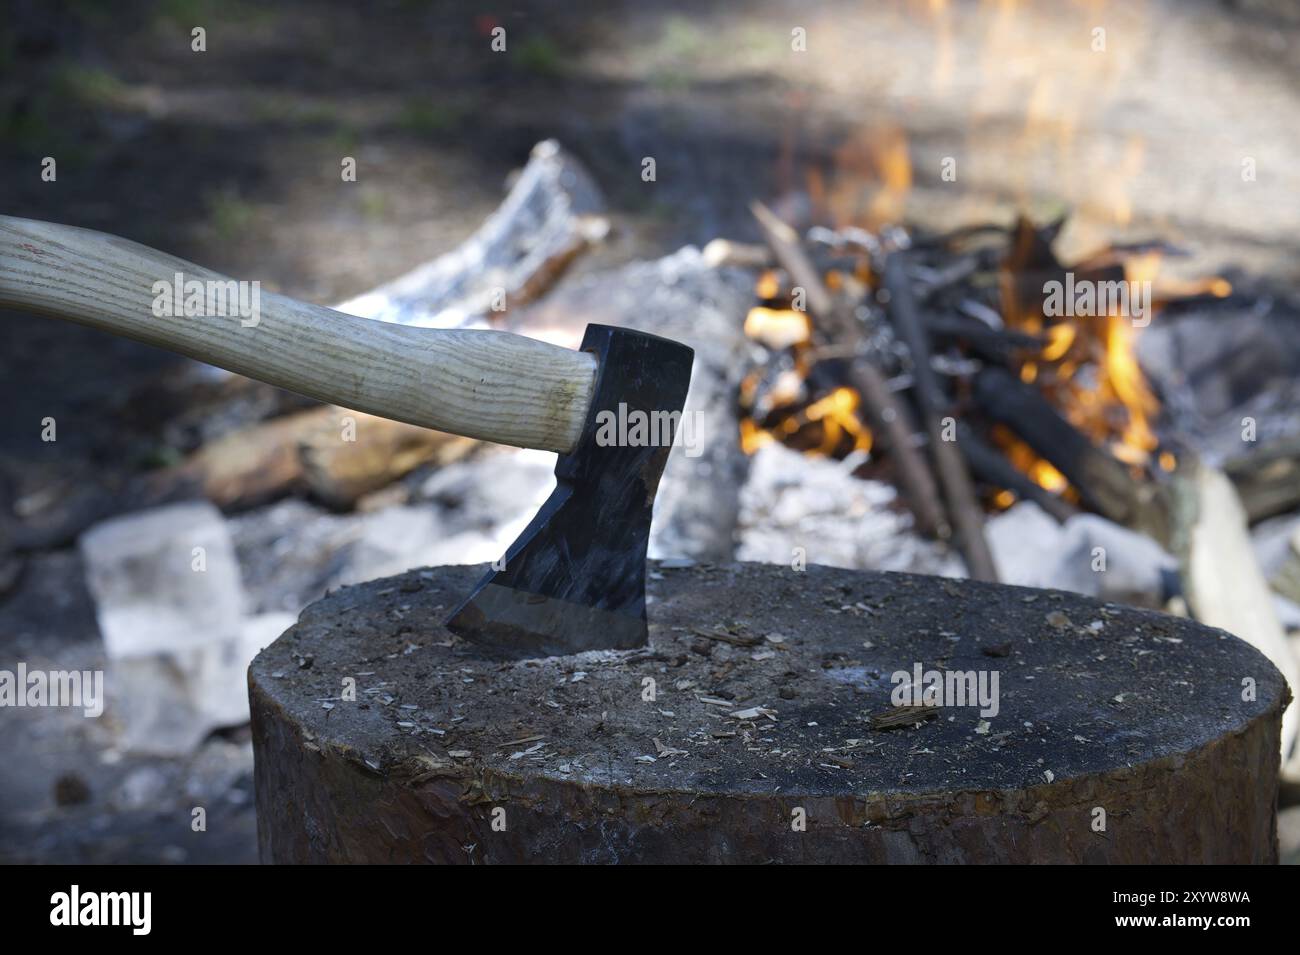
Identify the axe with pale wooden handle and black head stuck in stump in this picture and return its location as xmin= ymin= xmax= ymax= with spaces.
xmin=0 ymin=216 xmax=694 ymax=656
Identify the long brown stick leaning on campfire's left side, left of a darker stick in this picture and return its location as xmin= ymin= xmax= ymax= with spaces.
xmin=751 ymin=203 xmax=948 ymax=537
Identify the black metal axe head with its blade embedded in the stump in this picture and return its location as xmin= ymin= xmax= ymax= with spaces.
xmin=447 ymin=325 xmax=694 ymax=656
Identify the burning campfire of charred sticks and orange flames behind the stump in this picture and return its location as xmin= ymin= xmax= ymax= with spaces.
xmin=740 ymin=135 xmax=1232 ymax=577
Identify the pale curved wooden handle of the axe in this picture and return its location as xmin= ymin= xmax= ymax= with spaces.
xmin=0 ymin=216 xmax=595 ymax=453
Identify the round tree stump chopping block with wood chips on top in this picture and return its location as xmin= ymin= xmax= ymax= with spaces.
xmin=250 ymin=564 xmax=1287 ymax=863
